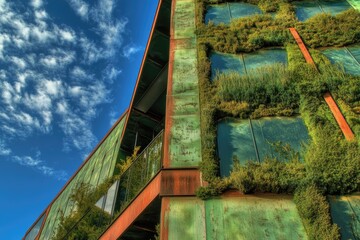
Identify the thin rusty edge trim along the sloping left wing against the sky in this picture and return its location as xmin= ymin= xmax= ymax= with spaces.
xmin=22 ymin=109 xmax=128 ymax=240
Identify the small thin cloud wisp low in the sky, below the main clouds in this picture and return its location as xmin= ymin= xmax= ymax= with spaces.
xmin=11 ymin=152 xmax=68 ymax=181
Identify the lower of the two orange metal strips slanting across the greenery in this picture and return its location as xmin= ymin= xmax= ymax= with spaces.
xmin=324 ymin=92 xmax=355 ymax=141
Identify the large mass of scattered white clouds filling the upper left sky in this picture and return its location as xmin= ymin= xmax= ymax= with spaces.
xmin=0 ymin=0 xmax=129 ymax=159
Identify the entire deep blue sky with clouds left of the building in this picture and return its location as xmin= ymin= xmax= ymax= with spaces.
xmin=0 ymin=0 xmax=157 ymax=239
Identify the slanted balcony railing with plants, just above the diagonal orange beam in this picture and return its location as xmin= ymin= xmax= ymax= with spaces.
xmin=55 ymin=131 xmax=163 ymax=239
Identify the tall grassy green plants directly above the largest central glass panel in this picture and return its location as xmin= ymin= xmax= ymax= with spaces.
xmin=214 ymin=64 xmax=299 ymax=109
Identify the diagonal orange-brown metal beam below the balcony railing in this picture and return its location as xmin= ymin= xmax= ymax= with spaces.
xmin=99 ymin=174 xmax=161 ymax=240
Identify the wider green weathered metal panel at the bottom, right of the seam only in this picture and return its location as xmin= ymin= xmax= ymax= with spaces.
xmin=205 ymin=196 xmax=307 ymax=240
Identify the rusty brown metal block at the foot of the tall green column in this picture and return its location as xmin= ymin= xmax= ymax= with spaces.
xmin=160 ymin=169 xmax=201 ymax=196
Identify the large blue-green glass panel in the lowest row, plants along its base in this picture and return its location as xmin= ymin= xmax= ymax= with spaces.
xmin=217 ymin=117 xmax=309 ymax=176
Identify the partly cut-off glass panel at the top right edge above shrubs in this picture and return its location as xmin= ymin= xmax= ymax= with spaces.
xmin=293 ymin=0 xmax=351 ymax=21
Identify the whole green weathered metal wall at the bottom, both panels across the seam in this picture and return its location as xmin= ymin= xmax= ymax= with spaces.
xmin=164 ymin=195 xmax=307 ymax=240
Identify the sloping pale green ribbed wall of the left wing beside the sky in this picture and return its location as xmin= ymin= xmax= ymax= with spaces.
xmin=40 ymin=117 xmax=126 ymax=239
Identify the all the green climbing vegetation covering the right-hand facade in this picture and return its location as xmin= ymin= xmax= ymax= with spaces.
xmin=196 ymin=0 xmax=360 ymax=239
